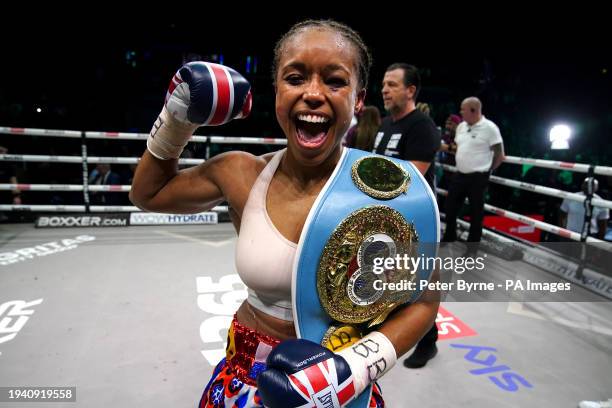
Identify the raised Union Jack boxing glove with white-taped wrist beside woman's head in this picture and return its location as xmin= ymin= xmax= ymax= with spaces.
xmin=147 ymin=61 xmax=252 ymax=160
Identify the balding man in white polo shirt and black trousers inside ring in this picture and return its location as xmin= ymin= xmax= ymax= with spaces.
xmin=442 ymin=97 xmax=505 ymax=242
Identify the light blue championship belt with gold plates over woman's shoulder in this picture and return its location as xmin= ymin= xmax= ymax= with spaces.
xmin=292 ymin=149 xmax=440 ymax=408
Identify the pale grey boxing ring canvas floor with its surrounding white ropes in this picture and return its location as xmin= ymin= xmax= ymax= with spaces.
xmin=0 ymin=128 xmax=612 ymax=408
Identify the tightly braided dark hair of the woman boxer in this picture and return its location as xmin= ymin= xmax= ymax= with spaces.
xmin=272 ymin=20 xmax=372 ymax=89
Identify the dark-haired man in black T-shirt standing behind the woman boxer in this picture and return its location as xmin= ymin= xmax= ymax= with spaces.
xmin=374 ymin=63 xmax=441 ymax=368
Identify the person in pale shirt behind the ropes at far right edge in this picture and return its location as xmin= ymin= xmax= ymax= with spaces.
xmin=559 ymin=178 xmax=610 ymax=239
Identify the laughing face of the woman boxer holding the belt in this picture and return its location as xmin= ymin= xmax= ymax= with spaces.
xmin=276 ymin=28 xmax=365 ymax=165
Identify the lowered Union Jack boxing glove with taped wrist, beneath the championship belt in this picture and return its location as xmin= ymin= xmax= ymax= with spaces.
xmin=257 ymin=332 xmax=397 ymax=408
